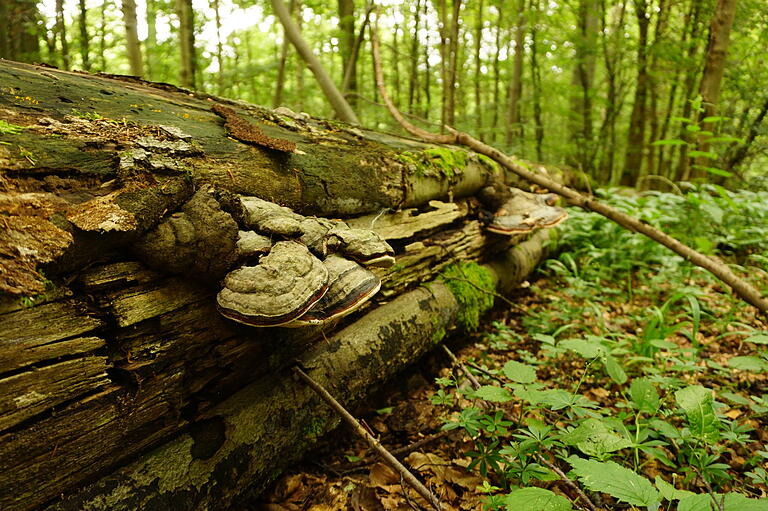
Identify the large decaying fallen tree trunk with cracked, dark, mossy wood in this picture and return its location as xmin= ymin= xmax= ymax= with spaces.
xmin=0 ymin=62 xmax=548 ymax=510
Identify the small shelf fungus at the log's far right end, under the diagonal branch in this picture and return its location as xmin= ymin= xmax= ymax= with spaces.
xmin=479 ymin=186 xmax=568 ymax=236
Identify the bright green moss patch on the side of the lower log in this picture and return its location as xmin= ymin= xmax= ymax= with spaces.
xmin=440 ymin=262 xmax=495 ymax=331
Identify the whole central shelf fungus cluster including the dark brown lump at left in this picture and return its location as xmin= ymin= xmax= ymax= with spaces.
xmin=136 ymin=191 xmax=395 ymax=327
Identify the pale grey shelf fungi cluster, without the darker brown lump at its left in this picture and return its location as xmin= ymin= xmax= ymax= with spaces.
xmin=216 ymin=197 xmax=395 ymax=327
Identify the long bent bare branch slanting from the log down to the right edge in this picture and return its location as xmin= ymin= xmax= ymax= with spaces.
xmin=371 ymin=21 xmax=768 ymax=314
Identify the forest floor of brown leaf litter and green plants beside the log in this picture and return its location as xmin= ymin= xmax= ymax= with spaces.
xmin=252 ymin=191 xmax=768 ymax=511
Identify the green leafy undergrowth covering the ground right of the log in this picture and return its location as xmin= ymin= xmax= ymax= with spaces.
xmin=432 ymin=187 xmax=768 ymax=511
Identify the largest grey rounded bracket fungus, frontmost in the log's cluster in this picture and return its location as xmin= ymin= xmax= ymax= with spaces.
xmin=216 ymin=241 xmax=328 ymax=326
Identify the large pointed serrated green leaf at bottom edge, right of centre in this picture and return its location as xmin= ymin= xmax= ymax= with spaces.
xmin=568 ymin=456 xmax=660 ymax=509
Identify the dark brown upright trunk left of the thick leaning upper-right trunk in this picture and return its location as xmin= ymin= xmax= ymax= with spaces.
xmin=621 ymin=0 xmax=650 ymax=186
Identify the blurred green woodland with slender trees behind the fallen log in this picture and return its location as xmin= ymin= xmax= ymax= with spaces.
xmin=0 ymin=0 xmax=768 ymax=188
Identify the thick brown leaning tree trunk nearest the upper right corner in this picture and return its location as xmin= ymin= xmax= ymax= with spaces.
xmin=694 ymin=0 xmax=738 ymax=177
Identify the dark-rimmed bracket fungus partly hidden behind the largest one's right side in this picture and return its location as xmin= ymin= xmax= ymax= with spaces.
xmin=287 ymin=254 xmax=381 ymax=326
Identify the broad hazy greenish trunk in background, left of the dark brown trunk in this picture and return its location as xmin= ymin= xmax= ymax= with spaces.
xmin=566 ymin=0 xmax=598 ymax=171
